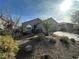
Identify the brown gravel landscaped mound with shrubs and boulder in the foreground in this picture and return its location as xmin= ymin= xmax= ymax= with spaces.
xmin=16 ymin=35 xmax=79 ymax=59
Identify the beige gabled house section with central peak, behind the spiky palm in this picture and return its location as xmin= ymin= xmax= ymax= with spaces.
xmin=38 ymin=17 xmax=58 ymax=33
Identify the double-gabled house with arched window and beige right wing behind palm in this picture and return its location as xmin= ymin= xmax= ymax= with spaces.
xmin=22 ymin=17 xmax=58 ymax=32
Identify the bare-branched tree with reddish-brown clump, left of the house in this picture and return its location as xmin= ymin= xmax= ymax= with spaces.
xmin=0 ymin=11 xmax=20 ymax=32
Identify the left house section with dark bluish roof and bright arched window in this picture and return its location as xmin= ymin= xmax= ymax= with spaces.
xmin=22 ymin=18 xmax=42 ymax=31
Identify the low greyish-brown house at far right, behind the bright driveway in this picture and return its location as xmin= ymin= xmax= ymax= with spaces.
xmin=58 ymin=22 xmax=79 ymax=33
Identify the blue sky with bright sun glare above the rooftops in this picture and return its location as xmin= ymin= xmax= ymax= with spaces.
xmin=0 ymin=0 xmax=79 ymax=22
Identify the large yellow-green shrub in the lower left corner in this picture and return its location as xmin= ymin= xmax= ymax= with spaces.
xmin=0 ymin=35 xmax=19 ymax=59
